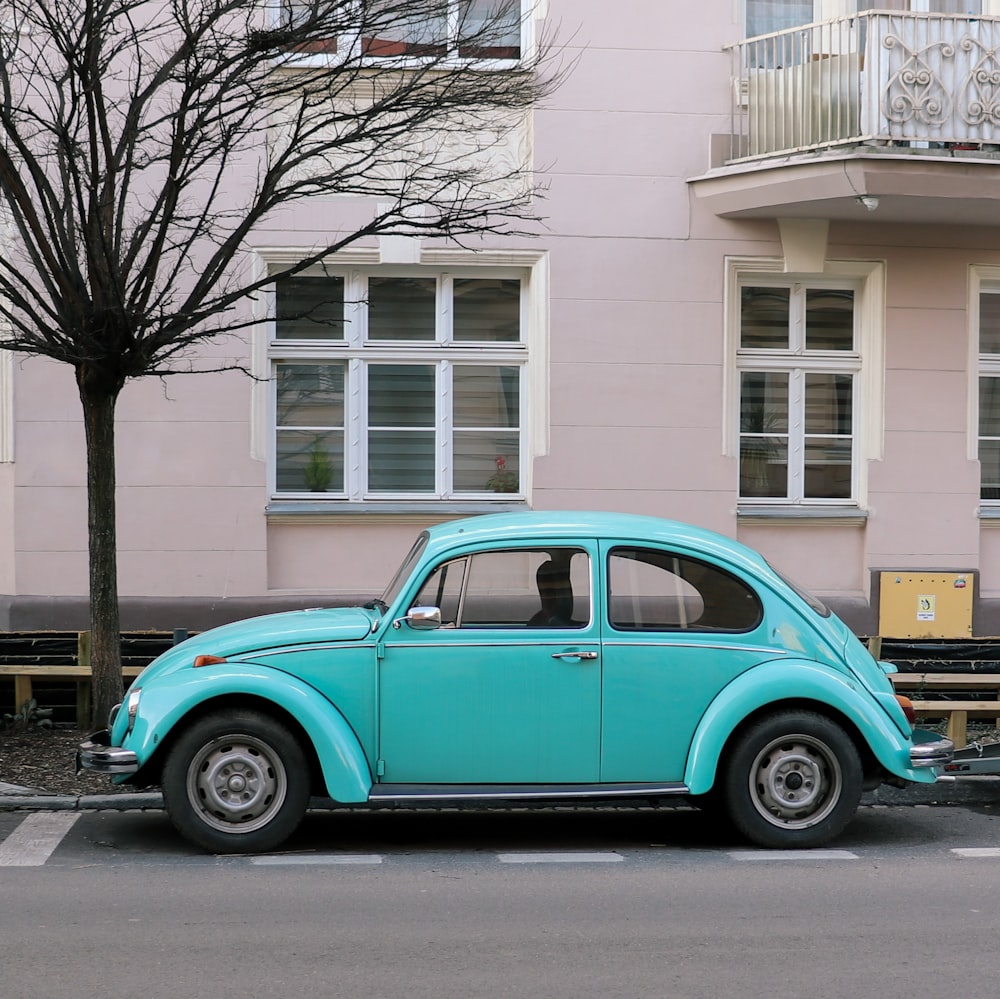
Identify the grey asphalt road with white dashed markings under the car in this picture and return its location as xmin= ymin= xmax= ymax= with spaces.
xmin=0 ymin=805 xmax=1000 ymax=999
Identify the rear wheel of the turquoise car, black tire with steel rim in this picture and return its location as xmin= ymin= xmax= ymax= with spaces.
xmin=724 ymin=711 xmax=862 ymax=849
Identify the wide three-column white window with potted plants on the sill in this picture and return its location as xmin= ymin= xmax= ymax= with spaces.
xmin=271 ymin=270 xmax=527 ymax=501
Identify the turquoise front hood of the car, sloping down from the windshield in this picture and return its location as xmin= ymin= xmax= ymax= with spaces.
xmin=136 ymin=607 xmax=379 ymax=686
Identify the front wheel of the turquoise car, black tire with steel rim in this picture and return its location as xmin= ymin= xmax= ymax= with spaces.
xmin=163 ymin=710 xmax=309 ymax=853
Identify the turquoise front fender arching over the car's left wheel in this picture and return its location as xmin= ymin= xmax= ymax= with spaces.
xmin=118 ymin=662 xmax=372 ymax=802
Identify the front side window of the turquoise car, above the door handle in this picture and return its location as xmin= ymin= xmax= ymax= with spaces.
xmin=414 ymin=548 xmax=592 ymax=628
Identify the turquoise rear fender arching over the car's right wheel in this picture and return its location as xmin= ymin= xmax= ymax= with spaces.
xmin=684 ymin=659 xmax=936 ymax=794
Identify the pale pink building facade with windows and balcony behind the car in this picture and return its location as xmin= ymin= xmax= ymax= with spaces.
xmin=0 ymin=0 xmax=1000 ymax=637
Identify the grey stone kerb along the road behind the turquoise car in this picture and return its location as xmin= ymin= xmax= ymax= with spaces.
xmin=0 ymin=776 xmax=1000 ymax=812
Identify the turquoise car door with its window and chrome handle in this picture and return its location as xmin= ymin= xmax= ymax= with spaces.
xmin=378 ymin=545 xmax=601 ymax=784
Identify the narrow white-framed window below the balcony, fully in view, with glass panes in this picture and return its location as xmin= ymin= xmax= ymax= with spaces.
xmin=736 ymin=279 xmax=861 ymax=503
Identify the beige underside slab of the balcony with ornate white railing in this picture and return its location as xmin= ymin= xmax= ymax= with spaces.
xmin=689 ymin=146 xmax=1000 ymax=226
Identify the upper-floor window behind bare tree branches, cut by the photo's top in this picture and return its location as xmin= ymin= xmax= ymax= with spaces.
xmin=284 ymin=0 xmax=525 ymax=61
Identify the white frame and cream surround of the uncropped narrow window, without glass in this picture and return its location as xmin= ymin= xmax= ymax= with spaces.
xmin=723 ymin=257 xmax=885 ymax=516
